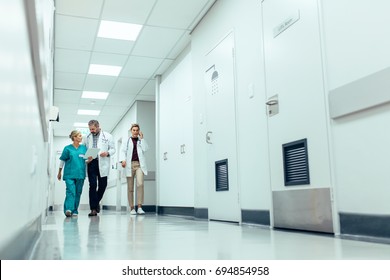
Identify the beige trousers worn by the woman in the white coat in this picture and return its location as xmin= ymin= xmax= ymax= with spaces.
xmin=127 ymin=161 xmax=144 ymax=208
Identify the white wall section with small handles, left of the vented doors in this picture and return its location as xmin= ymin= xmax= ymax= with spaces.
xmin=157 ymin=48 xmax=195 ymax=207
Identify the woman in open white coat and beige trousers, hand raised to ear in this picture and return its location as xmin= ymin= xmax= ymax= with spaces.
xmin=121 ymin=124 xmax=149 ymax=215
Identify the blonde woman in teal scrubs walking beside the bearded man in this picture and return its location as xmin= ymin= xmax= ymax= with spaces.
xmin=57 ymin=130 xmax=87 ymax=217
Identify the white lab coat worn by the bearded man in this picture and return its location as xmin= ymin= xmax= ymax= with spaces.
xmin=84 ymin=130 xmax=116 ymax=177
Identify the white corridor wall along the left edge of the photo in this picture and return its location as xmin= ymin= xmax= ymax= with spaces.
xmin=0 ymin=1 xmax=52 ymax=259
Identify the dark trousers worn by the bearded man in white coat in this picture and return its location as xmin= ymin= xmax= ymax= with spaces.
xmin=87 ymin=159 xmax=107 ymax=210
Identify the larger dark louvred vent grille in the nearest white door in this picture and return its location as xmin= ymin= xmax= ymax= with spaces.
xmin=283 ymin=139 xmax=310 ymax=186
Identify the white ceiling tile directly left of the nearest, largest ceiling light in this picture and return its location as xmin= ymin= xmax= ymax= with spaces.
xmin=55 ymin=15 xmax=99 ymax=51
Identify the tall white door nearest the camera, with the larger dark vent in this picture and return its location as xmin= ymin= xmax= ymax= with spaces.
xmin=262 ymin=0 xmax=332 ymax=231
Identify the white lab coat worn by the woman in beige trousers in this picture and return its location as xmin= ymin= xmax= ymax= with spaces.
xmin=121 ymin=137 xmax=149 ymax=177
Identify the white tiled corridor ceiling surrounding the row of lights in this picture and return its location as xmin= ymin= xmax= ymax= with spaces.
xmin=53 ymin=0 xmax=215 ymax=136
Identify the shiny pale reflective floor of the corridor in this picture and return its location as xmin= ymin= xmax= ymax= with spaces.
xmin=31 ymin=210 xmax=390 ymax=260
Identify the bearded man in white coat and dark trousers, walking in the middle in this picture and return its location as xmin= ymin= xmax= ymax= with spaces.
xmin=85 ymin=120 xmax=115 ymax=217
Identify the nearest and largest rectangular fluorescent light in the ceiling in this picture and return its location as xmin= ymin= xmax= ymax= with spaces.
xmin=98 ymin=20 xmax=142 ymax=41
